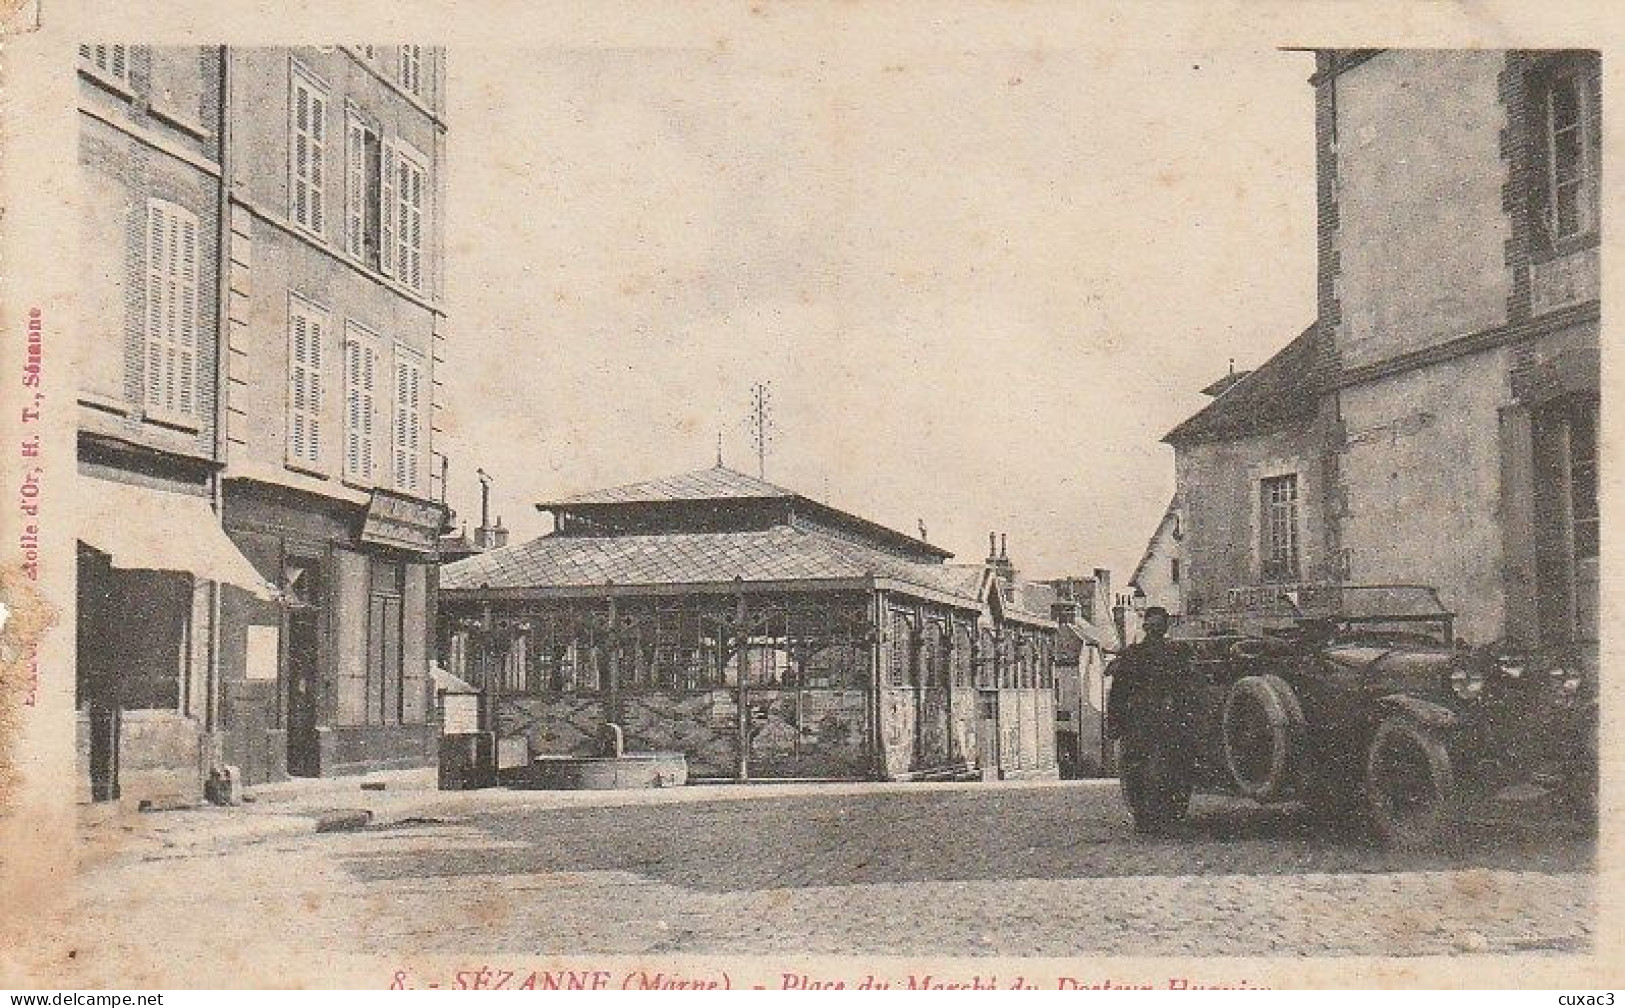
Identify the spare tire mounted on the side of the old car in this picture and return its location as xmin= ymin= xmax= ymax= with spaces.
xmin=1220 ymin=675 xmax=1303 ymax=802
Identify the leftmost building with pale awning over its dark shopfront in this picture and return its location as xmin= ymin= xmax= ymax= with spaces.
xmin=75 ymin=46 xmax=271 ymax=800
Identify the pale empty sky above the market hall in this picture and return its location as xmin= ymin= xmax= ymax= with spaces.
xmin=439 ymin=35 xmax=1315 ymax=584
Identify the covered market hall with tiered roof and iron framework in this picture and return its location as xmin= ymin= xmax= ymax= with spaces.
xmin=440 ymin=465 xmax=1056 ymax=780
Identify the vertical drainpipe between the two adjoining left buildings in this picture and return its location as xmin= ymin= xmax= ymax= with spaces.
xmin=203 ymin=46 xmax=232 ymax=736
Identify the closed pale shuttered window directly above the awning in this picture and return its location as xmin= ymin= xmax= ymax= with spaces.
xmin=143 ymin=200 xmax=198 ymax=418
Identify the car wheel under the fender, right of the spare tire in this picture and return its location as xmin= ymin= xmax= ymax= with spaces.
xmin=1365 ymin=715 xmax=1458 ymax=847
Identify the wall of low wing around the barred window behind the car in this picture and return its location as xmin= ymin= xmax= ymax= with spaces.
xmin=1175 ymin=419 xmax=1337 ymax=613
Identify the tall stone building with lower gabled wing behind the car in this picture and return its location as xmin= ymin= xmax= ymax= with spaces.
xmin=1167 ymin=50 xmax=1601 ymax=660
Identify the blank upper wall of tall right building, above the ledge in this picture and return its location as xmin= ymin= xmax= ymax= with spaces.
xmin=1328 ymin=50 xmax=1511 ymax=367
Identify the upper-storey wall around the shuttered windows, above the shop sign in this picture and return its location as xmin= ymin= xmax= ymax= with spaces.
xmin=228 ymin=47 xmax=445 ymax=502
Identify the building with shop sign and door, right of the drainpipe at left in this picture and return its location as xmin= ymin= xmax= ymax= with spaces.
xmin=221 ymin=46 xmax=445 ymax=782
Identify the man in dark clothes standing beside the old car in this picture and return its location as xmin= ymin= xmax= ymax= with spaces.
xmin=1107 ymin=605 xmax=1194 ymax=832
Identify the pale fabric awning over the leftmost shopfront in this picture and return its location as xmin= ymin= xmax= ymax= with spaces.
xmin=75 ymin=476 xmax=280 ymax=600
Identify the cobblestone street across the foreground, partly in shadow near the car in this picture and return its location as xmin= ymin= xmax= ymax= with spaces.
xmin=57 ymin=782 xmax=1594 ymax=967
